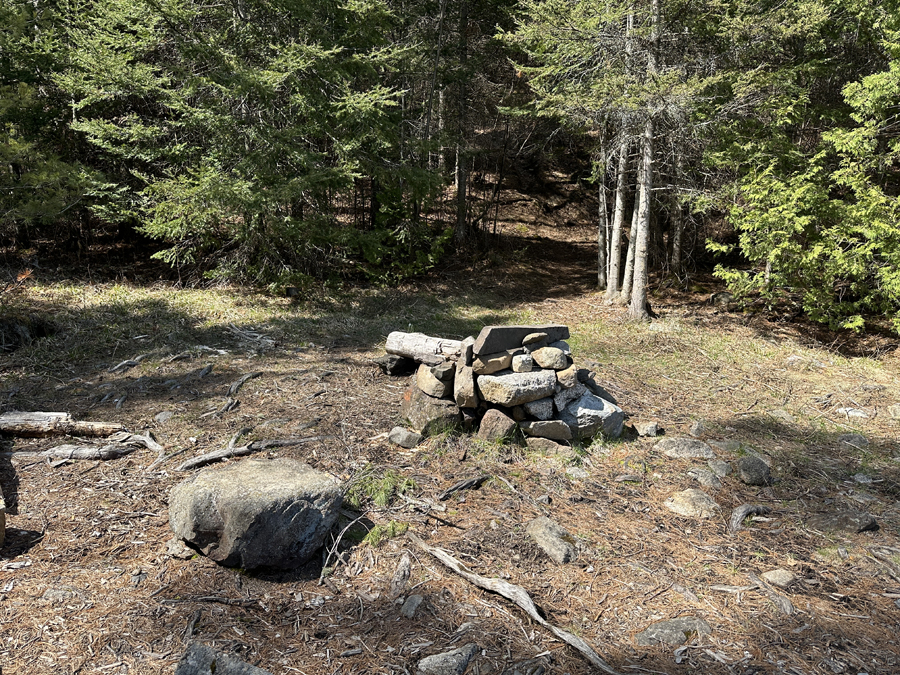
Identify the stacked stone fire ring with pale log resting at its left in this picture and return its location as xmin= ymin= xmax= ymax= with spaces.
xmin=385 ymin=324 xmax=625 ymax=441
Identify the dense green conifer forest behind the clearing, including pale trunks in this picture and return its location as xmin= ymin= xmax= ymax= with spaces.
xmin=0 ymin=0 xmax=900 ymax=330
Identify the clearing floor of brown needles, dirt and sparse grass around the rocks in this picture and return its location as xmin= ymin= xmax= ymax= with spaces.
xmin=0 ymin=180 xmax=900 ymax=675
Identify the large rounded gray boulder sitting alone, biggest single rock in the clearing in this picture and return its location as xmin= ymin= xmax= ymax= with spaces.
xmin=169 ymin=458 xmax=343 ymax=569
